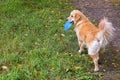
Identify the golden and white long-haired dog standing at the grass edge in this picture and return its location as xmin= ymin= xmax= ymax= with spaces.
xmin=67 ymin=10 xmax=115 ymax=72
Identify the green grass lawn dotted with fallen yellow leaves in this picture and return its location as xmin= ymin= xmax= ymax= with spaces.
xmin=0 ymin=0 xmax=99 ymax=80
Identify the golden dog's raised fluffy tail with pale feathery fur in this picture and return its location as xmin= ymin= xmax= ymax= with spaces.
xmin=97 ymin=18 xmax=115 ymax=47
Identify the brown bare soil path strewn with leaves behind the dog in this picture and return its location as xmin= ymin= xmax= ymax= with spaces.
xmin=73 ymin=0 xmax=120 ymax=80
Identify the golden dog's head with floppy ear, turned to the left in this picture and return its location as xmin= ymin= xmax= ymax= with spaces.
xmin=67 ymin=10 xmax=82 ymax=24
